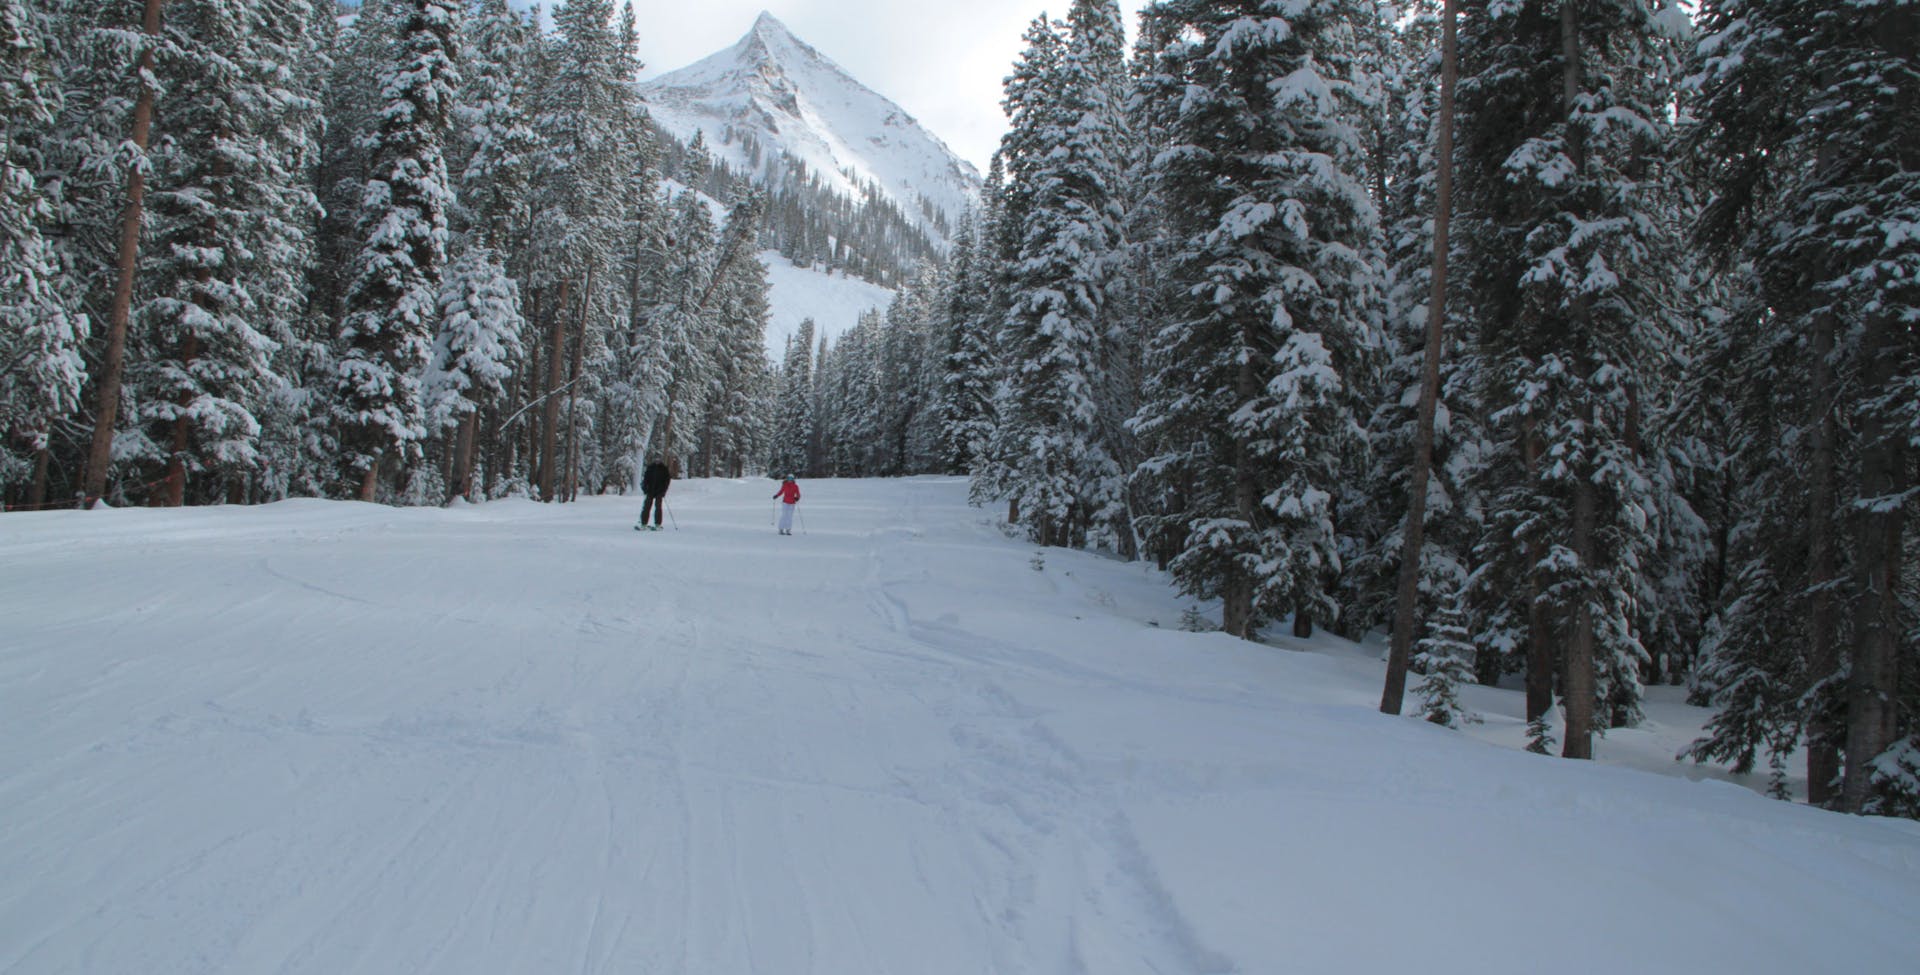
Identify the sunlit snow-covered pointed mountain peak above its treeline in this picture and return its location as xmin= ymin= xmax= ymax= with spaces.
xmin=641 ymin=13 xmax=981 ymax=242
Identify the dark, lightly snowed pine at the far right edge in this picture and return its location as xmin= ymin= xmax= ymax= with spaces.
xmin=1692 ymin=0 xmax=1920 ymax=810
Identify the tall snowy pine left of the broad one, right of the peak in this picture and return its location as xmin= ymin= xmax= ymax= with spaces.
xmin=1000 ymin=0 xmax=1131 ymax=545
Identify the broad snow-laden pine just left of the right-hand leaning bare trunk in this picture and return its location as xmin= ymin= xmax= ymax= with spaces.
xmin=1135 ymin=0 xmax=1379 ymax=637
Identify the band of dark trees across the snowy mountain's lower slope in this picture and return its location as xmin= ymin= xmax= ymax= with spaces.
xmin=653 ymin=125 xmax=952 ymax=288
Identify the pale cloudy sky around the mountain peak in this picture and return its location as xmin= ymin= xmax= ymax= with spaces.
xmin=634 ymin=0 xmax=1139 ymax=177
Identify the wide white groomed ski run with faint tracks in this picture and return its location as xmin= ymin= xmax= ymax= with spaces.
xmin=0 ymin=478 xmax=1920 ymax=975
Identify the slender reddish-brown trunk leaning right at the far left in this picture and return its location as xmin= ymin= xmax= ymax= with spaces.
xmin=81 ymin=0 xmax=163 ymax=507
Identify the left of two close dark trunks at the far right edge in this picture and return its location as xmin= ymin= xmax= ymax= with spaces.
xmin=1807 ymin=315 xmax=1845 ymax=806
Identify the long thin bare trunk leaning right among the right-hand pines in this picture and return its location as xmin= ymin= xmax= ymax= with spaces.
xmin=1380 ymin=0 xmax=1459 ymax=714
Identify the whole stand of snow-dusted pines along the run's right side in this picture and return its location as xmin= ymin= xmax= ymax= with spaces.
xmin=774 ymin=0 xmax=1920 ymax=816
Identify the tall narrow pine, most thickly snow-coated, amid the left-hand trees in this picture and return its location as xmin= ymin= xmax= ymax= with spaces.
xmin=332 ymin=0 xmax=461 ymax=501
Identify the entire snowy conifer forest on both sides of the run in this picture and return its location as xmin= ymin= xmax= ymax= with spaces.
xmin=0 ymin=0 xmax=1920 ymax=816
